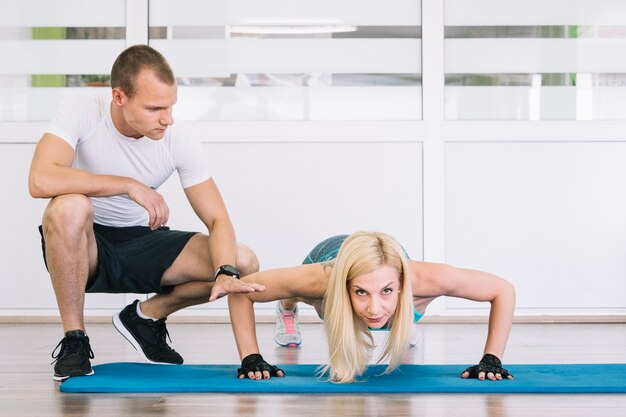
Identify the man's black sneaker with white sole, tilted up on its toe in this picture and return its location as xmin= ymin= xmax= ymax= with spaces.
xmin=113 ymin=300 xmax=183 ymax=365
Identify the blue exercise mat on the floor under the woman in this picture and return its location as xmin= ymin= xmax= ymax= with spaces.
xmin=60 ymin=362 xmax=626 ymax=394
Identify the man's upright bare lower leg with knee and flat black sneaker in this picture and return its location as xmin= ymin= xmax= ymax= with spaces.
xmin=42 ymin=194 xmax=98 ymax=381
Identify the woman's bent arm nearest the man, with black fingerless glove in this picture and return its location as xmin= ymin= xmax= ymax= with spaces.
xmin=228 ymin=264 xmax=326 ymax=380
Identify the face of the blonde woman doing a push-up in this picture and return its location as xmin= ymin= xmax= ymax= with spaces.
xmin=348 ymin=265 xmax=400 ymax=329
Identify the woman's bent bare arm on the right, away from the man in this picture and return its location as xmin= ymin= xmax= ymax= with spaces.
xmin=413 ymin=262 xmax=515 ymax=379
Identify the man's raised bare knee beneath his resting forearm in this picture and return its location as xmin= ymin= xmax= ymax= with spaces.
xmin=42 ymin=194 xmax=93 ymax=233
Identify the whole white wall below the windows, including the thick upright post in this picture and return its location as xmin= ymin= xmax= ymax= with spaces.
xmin=0 ymin=0 xmax=626 ymax=319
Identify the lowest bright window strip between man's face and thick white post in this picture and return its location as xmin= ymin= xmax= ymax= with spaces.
xmin=176 ymin=87 xmax=421 ymax=120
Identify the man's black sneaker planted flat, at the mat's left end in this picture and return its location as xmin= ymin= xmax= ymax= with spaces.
xmin=52 ymin=330 xmax=94 ymax=382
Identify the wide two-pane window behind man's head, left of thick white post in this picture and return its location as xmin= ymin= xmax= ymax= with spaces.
xmin=0 ymin=0 xmax=422 ymax=122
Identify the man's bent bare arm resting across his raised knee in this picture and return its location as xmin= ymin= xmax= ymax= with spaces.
xmin=28 ymin=133 xmax=169 ymax=229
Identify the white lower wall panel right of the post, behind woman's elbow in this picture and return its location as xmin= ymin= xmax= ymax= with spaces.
xmin=446 ymin=141 xmax=626 ymax=315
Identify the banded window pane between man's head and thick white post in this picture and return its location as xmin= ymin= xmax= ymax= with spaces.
xmin=149 ymin=0 xmax=422 ymax=120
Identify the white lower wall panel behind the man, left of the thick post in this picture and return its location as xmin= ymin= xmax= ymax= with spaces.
xmin=0 ymin=132 xmax=422 ymax=315
